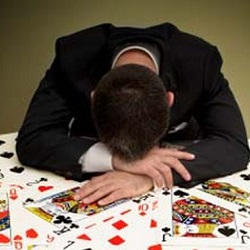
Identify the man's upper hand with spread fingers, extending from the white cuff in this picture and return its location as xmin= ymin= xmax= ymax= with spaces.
xmin=113 ymin=147 xmax=195 ymax=188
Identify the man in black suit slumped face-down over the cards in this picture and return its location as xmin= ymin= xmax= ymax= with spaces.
xmin=17 ymin=23 xmax=249 ymax=205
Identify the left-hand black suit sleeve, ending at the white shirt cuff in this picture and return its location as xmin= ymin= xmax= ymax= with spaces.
xmin=16 ymin=39 xmax=95 ymax=181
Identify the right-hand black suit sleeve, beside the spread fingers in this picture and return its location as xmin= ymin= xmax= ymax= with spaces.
xmin=174 ymin=49 xmax=249 ymax=187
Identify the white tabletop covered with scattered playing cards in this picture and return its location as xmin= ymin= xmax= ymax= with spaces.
xmin=0 ymin=134 xmax=250 ymax=250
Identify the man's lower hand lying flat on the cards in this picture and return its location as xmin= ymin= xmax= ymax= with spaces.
xmin=74 ymin=170 xmax=153 ymax=205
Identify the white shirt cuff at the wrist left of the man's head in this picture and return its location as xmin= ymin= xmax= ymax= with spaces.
xmin=78 ymin=142 xmax=113 ymax=173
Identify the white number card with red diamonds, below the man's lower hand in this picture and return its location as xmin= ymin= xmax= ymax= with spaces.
xmin=44 ymin=190 xmax=157 ymax=250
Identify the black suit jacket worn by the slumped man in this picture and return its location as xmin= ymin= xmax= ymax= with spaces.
xmin=17 ymin=23 xmax=249 ymax=186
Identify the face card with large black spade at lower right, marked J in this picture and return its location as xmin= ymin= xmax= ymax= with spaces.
xmin=158 ymin=188 xmax=249 ymax=246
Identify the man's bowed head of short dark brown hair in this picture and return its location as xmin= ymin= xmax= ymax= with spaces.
xmin=92 ymin=64 xmax=169 ymax=161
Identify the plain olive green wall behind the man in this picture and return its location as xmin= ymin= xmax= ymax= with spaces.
xmin=0 ymin=0 xmax=250 ymax=135
